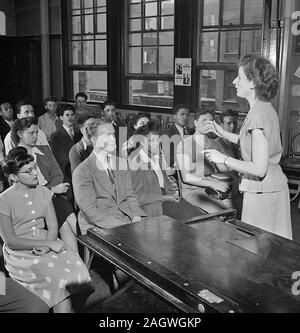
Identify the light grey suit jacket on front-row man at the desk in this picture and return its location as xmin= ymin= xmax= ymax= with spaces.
xmin=73 ymin=153 xmax=146 ymax=233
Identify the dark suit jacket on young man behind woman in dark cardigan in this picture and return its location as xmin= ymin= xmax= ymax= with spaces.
xmin=50 ymin=127 xmax=82 ymax=182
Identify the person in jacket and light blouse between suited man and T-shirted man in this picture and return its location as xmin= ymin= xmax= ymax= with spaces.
xmin=128 ymin=121 xmax=203 ymax=220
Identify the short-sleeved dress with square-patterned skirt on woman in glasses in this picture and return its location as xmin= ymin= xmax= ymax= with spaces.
xmin=0 ymin=186 xmax=91 ymax=307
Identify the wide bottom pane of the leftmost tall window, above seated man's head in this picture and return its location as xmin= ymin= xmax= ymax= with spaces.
xmin=73 ymin=71 xmax=107 ymax=102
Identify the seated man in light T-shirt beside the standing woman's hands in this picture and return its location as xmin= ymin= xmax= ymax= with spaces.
xmin=177 ymin=111 xmax=240 ymax=213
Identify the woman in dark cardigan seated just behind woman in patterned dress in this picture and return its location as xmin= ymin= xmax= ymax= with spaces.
xmin=12 ymin=117 xmax=78 ymax=252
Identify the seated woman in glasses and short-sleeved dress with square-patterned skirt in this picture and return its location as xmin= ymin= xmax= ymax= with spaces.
xmin=0 ymin=148 xmax=92 ymax=312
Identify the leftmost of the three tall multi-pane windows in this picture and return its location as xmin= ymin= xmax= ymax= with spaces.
xmin=68 ymin=0 xmax=107 ymax=102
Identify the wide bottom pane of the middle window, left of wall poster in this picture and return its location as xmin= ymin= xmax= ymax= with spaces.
xmin=129 ymin=80 xmax=174 ymax=107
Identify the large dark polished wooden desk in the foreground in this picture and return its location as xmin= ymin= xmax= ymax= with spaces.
xmin=79 ymin=217 xmax=300 ymax=313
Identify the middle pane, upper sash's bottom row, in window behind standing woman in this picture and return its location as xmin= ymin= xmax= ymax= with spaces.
xmin=220 ymin=31 xmax=240 ymax=62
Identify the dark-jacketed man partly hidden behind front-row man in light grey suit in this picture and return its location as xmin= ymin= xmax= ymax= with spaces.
xmin=69 ymin=114 xmax=102 ymax=174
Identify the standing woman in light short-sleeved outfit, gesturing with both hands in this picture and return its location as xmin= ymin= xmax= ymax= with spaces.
xmin=205 ymin=55 xmax=292 ymax=239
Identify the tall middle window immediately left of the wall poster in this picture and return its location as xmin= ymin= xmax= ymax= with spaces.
xmin=126 ymin=0 xmax=174 ymax=107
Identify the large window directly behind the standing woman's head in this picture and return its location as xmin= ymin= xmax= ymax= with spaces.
xmin=198 ymin=0 xmax=264 ymax=112
